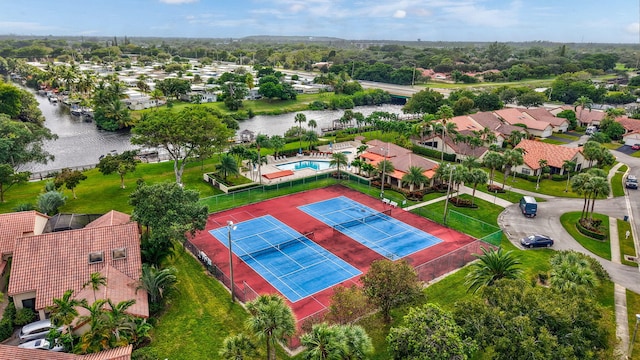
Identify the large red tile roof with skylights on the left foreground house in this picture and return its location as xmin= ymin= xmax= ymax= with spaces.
xmin=8 ymin=222 xmax=149 ymax=317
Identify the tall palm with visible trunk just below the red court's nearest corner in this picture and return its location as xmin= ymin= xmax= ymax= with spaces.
xmin=246 ymin=294 xmax=296 ymax=360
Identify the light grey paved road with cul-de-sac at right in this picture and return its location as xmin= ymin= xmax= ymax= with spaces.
xmin=498 ymin=151 xmax=640 ymax=294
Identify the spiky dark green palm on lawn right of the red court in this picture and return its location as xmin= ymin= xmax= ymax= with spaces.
xmin=465 ymin=247 xmax=522 ymax=294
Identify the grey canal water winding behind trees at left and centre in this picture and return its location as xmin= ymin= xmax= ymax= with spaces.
xmin=23 ymin=82 xmax=402 ymax=172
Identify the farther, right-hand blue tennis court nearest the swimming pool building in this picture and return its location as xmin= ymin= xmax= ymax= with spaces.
xmin=299 ymin=196 xmax=442 ymax=260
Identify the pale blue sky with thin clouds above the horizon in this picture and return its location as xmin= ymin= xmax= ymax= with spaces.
xmin=0 ymin=0 xmax=640 ymax=44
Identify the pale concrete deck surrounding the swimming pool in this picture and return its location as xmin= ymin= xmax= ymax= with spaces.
xmin=242 ymin=141 xmax=362 ymax=184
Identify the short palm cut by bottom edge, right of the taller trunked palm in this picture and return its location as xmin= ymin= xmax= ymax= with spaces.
xmin=300 ymin=323 xmax=347 ymax=360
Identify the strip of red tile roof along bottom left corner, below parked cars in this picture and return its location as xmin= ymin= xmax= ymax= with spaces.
xmin=0 ymin=344 xmax=133 ymax=360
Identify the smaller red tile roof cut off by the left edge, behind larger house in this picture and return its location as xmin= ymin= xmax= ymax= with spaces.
xmin=0 ymin=211 xmax=49 ymax=255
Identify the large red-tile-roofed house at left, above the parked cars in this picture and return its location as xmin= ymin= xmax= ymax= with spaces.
xmin=8 ymin=212 xmax=149 ymax=320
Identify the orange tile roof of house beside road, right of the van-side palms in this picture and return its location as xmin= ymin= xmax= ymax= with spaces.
xmin=515 ymin=140 xmax=582 ymax=170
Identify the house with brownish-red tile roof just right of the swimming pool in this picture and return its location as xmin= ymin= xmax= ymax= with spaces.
xmin=360 ymin=140 xmax=438 ymax=191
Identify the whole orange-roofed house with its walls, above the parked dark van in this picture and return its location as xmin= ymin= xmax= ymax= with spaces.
xmin=513 ymin=140 xmax=589 ymax=175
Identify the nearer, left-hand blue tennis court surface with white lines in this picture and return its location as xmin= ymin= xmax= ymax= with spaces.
xmin=209 ymin=215 xmax=362 ymax=302
